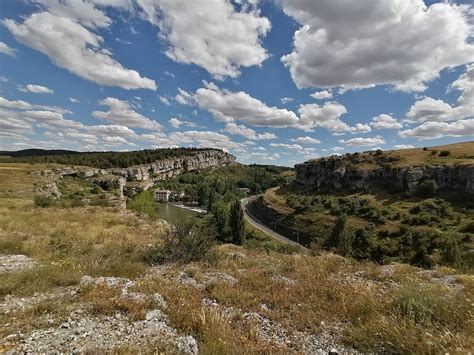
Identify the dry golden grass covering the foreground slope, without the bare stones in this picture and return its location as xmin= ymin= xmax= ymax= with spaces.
xmin=0 ymin=164 xmax=474 ymax=354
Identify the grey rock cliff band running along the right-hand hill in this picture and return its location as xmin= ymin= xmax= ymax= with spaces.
xmin=295 ymin=157 xmax=474 ymax=193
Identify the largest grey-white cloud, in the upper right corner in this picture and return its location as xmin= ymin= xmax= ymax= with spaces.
xmin=280 ymin=0 xmax=474 ymax=91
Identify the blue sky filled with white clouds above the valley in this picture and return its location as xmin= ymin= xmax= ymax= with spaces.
xmin=0 ymin=0 xmax=474 ymax=166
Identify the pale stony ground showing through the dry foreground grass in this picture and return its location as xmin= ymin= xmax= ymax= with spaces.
xmin=0 ymin=255 xmax=360 ymax=354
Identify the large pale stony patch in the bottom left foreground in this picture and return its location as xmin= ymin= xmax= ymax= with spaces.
xmin=7 ymin=309 xmax=198 ymax=354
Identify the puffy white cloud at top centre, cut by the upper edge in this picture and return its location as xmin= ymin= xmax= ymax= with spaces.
xmin=137 ymin=0 xmax=271 ymax=79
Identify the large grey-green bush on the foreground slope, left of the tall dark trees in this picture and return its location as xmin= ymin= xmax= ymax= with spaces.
xmin=145 ymin=219 xmax=216 ymax=264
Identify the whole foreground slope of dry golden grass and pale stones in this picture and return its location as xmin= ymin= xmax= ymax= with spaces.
xmin=0 ymin=163 xmax=474 ymax=354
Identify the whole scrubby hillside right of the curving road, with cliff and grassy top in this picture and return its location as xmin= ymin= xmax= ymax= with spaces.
xmin=251 ymin=142 xmax=474 ymax=272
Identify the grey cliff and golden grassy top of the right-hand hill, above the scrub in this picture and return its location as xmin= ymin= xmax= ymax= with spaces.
xmin=295 ymin=142 xmax=474 ymax=194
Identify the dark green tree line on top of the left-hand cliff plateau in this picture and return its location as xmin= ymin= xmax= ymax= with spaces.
xmin=11 ymin=148 xmax=220 ymax=169
